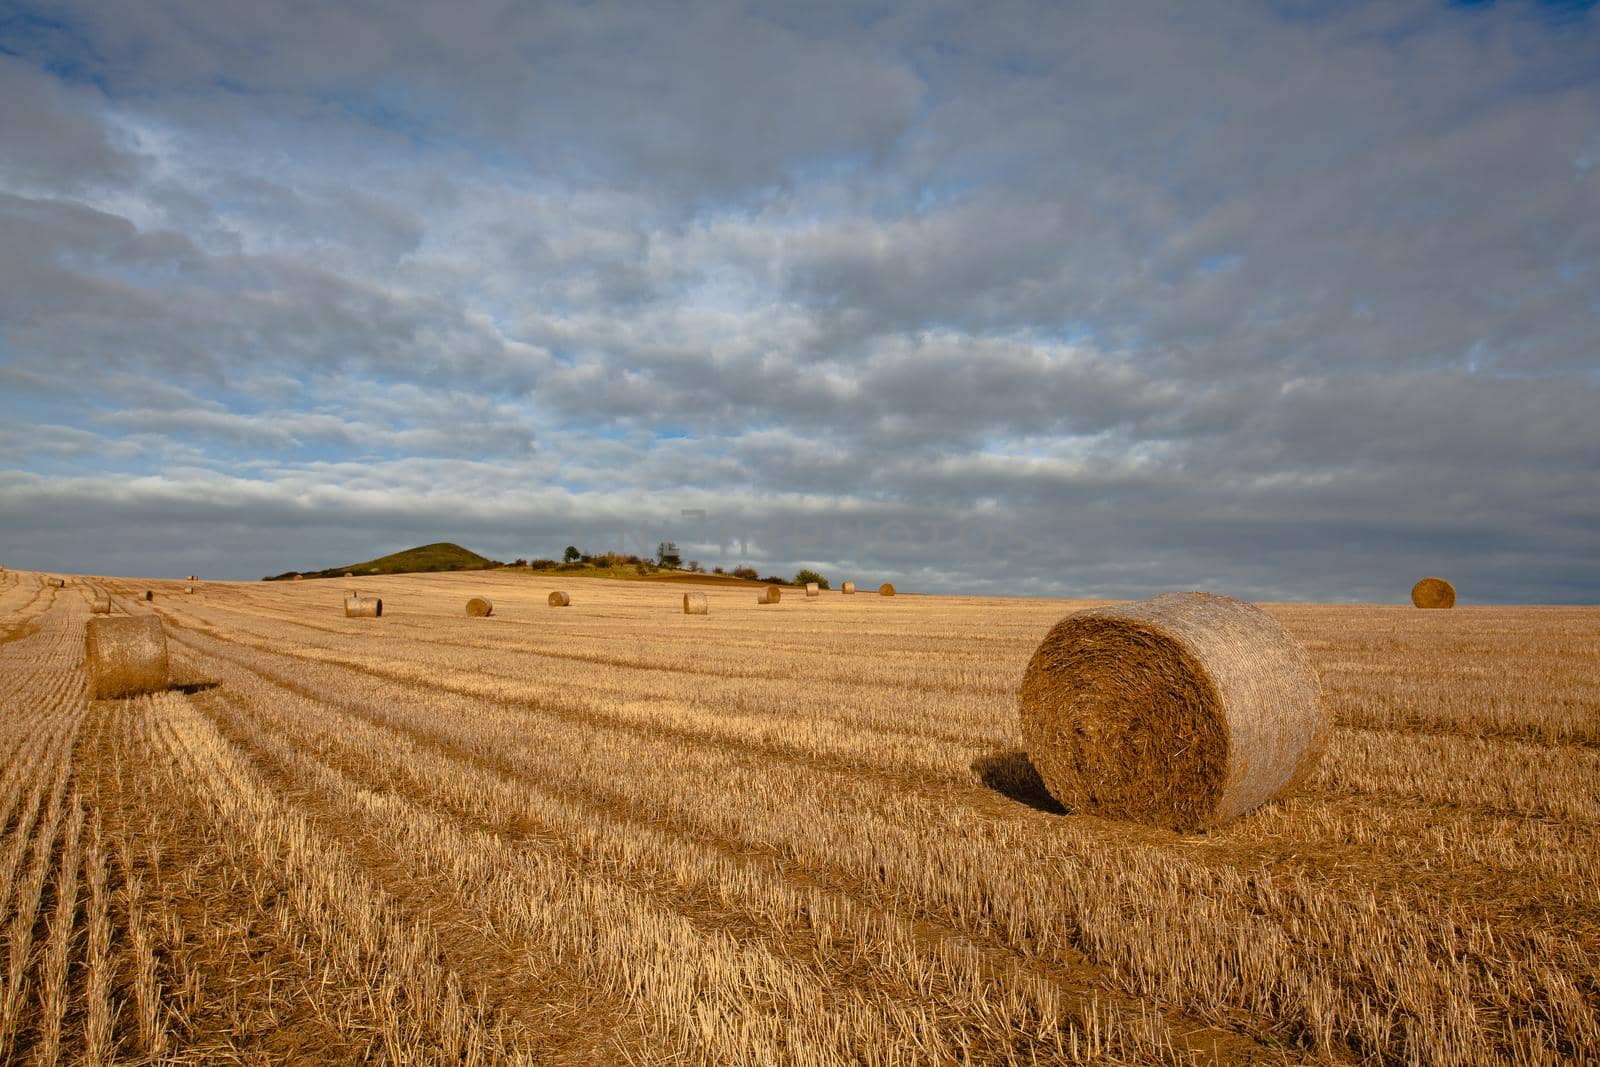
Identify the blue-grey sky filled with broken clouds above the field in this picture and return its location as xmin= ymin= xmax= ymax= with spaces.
xmin=0 ymin=0 xmax=1600 ymax=603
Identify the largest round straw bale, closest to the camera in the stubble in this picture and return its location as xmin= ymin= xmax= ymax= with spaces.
xmin=1018 ymin=593 xmax=1326 ymax=830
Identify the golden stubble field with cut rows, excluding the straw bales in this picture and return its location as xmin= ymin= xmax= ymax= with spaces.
xmin=0 ymin=571 xmax=1600 ymax=1064
